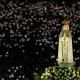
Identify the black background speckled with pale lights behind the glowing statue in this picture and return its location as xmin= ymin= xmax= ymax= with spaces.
xmin=0 ymin=0 xmax=80 ymax=80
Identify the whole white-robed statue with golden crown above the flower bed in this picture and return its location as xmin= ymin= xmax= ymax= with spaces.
xmin=58 ymin=20 xmax=74 ymax=64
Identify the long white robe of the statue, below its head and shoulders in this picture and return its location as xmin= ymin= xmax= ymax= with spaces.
xmin=58 ymin=31 xmax=73 ymax=64
